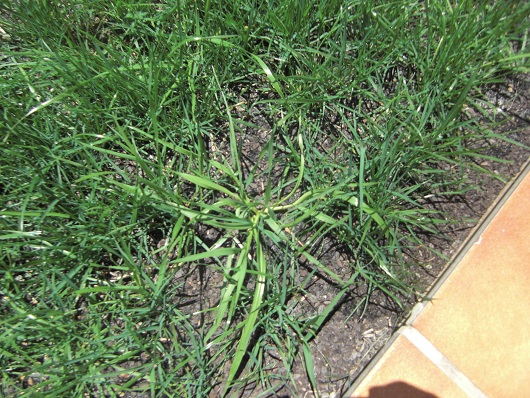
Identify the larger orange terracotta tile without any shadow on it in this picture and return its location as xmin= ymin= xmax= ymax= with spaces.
xmin=413 ymin=174 xmax=530 ymax=397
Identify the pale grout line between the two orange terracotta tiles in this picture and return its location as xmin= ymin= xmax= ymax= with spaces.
xmin=401 ymin=325 xmax=487 ymax=398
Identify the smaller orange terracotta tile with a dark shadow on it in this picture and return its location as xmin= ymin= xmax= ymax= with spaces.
xmin=351 ymin=336 xmax=466 ymax=398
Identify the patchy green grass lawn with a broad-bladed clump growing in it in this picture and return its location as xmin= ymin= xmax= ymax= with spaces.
xmin=0 ymin=0 xmax=530 ymax=397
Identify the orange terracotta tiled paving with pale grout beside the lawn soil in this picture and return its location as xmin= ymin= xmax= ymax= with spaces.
xmin=346 ymin=163 xmax=530 ymax=398
